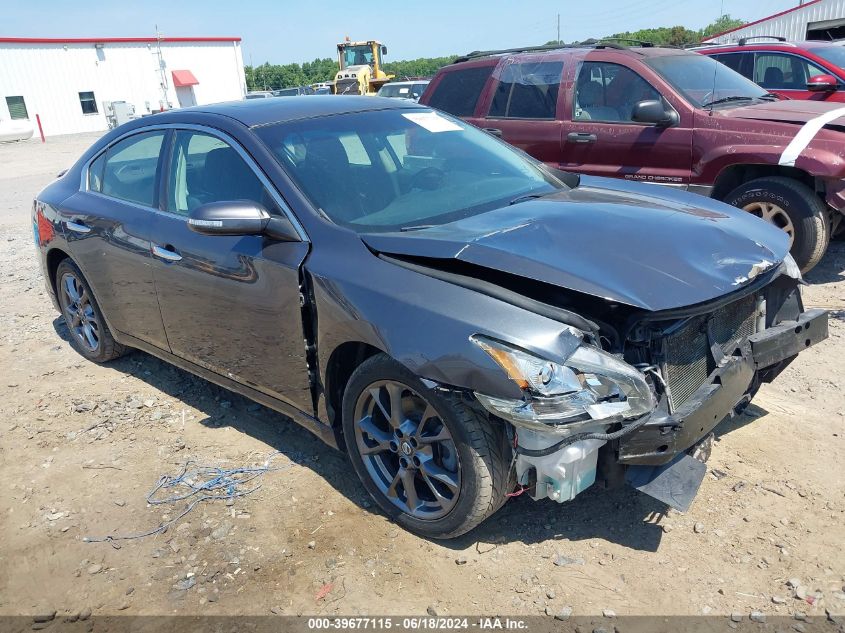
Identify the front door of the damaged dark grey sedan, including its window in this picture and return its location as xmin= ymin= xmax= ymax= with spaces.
xmin=152 ymin=128 xmax=311 ymax=411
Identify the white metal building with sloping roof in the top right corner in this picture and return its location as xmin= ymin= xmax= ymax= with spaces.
xmin=704 ymin=0 xmax=845 ymax=44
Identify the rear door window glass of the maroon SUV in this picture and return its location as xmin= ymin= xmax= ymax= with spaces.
xmin=488 ymin=62 xmax=563 ymax=119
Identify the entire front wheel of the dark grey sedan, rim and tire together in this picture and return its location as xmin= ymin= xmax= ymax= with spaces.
xmin=343 ymin=354 xmax=511 ymax=538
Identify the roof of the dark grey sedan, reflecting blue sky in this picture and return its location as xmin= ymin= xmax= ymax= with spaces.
xmin=186 ymin=95 xmax=425 ymax=127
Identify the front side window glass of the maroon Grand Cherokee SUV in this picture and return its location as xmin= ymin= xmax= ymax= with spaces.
xmin=572 ymin=62 xmax=660 ymax=123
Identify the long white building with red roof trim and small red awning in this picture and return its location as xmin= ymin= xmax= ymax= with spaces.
xmin=0 ymin=37 xmax=246 ymax=136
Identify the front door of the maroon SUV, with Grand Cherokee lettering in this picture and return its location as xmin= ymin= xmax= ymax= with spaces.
xmin=561 ymin=61 xmax=692 ymax=185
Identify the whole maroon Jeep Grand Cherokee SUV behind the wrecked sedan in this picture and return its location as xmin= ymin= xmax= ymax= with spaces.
xmin=420 ymin=44 xmax=845 ymax=272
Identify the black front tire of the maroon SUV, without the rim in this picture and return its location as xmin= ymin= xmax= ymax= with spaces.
xmin=724 ymin=176 xmax=830 ymax=273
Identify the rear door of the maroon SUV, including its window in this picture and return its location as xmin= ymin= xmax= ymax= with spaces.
xmin=471 ymin=59 xmax=563 ymax=167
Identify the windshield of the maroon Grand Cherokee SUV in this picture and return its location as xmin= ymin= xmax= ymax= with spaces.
xmin=646 ymin=54 xmax=769 ymax=108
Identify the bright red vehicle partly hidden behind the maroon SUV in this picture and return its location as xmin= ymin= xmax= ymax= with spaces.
xmin=692 ymin=37 xmax=845 ymax=103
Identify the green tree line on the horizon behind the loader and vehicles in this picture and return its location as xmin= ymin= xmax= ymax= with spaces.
xmin=244 ymin=14 xmax=744 ymax=90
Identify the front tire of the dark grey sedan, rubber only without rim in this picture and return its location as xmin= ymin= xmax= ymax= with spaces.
xmin=343 ymin=354 xmax=513 ymax=539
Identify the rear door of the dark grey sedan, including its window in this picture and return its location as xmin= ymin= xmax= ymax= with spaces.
xmin=60 ymin=130 xmax=168 ymax=350
